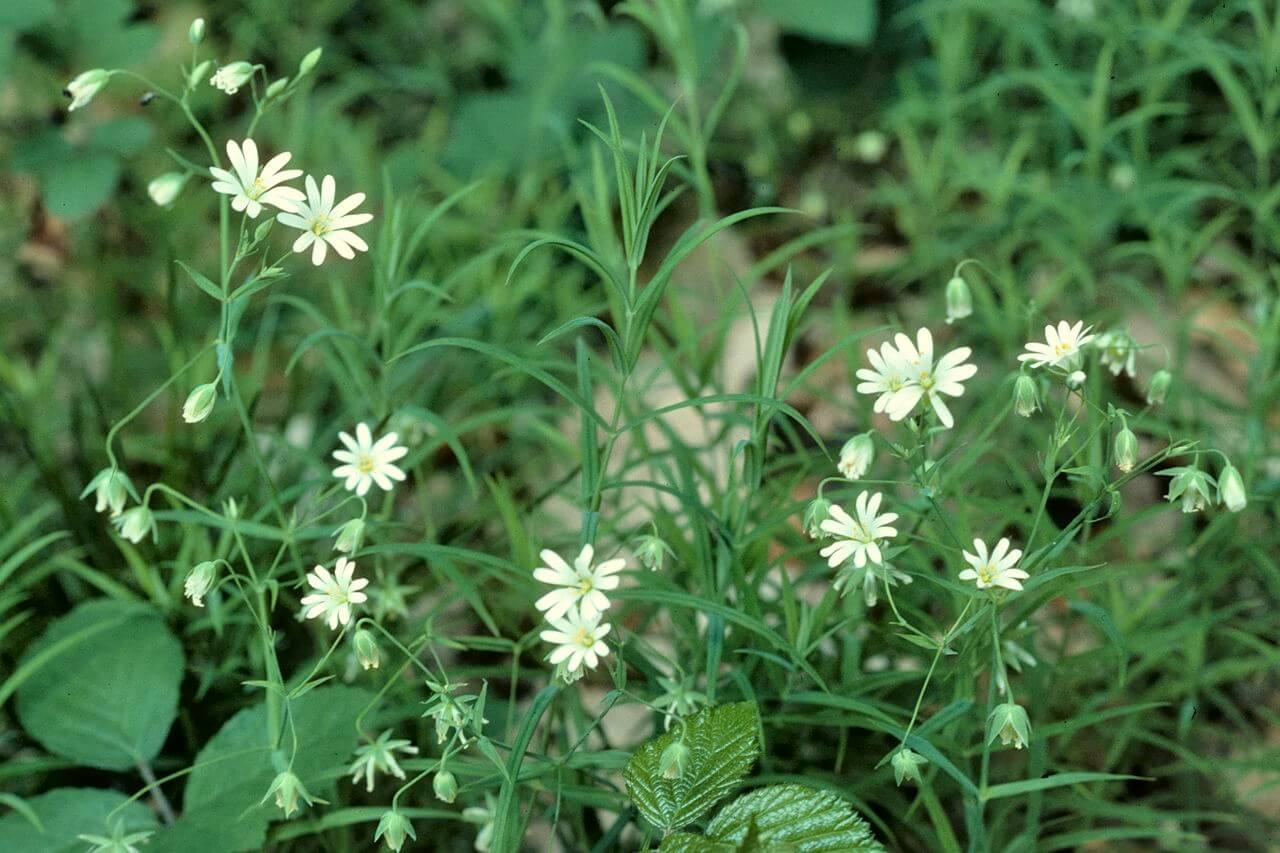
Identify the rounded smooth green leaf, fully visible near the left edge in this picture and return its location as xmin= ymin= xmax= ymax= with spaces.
xmin=18 ymin=601 xmax=184 ymax=770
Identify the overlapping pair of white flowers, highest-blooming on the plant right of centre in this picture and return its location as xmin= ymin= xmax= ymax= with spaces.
xmin=858 ymin=329 xmax=978 ymax=429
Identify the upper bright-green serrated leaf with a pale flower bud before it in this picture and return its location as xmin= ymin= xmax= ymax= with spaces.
xmin=622 ymin=702 xmax=760 ymax=833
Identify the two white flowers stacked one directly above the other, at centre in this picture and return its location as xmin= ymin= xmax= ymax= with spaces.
xmin=534 ymin=544 xmax=626 ymax=681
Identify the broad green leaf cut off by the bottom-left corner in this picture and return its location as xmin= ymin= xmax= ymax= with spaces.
xmin=0 ymin=788 xmax=156 ymax=853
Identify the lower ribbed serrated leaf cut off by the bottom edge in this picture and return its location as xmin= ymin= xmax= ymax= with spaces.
xmin=658 ymin=785 xmax=884 ymax=853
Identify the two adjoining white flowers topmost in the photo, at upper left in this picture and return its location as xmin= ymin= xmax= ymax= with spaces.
xmin=209 ymin=140 xmax=374 ymax=266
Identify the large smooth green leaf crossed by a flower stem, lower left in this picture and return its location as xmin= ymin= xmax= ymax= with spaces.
xmin=146 ymin=686 xmax=372 ymax=853
